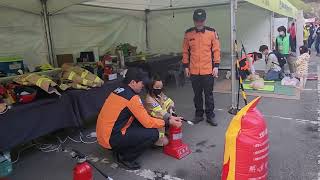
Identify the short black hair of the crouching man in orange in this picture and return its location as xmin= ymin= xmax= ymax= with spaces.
xmin=123 ymin=68 xmax=150 ymax=84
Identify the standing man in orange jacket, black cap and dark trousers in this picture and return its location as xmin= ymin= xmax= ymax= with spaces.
xmin=182 ymin=9 xmax=220 ymax=126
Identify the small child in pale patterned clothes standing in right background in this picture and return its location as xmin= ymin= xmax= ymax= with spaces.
xmin=295 ymin=46 xmax=310 ymax=89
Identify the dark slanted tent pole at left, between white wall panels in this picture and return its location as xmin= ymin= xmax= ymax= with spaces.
xmin=40 ymin=0 xmax=56 ymax=66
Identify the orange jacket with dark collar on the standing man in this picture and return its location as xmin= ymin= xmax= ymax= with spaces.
xmin=182 ymin=27 xmax=221 ymax=75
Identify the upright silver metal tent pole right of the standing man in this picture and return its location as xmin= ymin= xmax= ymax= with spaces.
xmin=229 ymin=0 xmax=238 ymax=114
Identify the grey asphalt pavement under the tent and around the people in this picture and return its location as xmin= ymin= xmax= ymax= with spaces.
xmin=6 ymin=54 xmax=320 ymax=180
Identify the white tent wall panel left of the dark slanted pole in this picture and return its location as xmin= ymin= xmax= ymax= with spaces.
xmin=0 ymin=7 xmax=47 ymax=69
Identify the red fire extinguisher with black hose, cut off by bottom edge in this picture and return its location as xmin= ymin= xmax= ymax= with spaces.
xmin=71 ymin=150 xmax=112 ymax=180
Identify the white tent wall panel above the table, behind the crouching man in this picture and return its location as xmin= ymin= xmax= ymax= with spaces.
xmin=51 ymin=6 xmax=145 ymax=57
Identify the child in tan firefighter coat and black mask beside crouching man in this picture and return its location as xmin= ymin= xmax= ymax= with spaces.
xmin=145 ymin=76 xmax=175 ymax=146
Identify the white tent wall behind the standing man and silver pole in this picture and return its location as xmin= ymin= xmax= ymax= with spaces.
xmin=149 ymin=3 xmax=271 ymax=53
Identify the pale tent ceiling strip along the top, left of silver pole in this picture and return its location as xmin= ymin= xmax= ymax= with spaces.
xmin=0 ymin=0 xmax=229 ymax=14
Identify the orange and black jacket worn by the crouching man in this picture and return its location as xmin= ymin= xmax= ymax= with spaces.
xmin=96 ymin=86 xmax=167 ymax=149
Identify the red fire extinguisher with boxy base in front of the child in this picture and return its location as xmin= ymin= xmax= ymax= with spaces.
xmin=164 ymin=127 xmax=191 ymax=159
